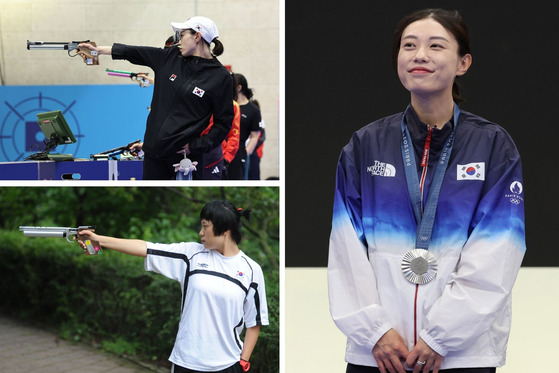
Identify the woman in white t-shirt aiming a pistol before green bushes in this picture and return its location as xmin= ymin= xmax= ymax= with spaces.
xmin=79 ymin=201 xmax=268 ymax=373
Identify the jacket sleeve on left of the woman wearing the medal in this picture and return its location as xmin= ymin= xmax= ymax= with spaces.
xmin=328 ymin=141 xmax=392 ymax=350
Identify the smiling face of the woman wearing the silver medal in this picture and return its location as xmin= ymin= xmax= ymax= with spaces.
xmin=397 ymin=18 xmax=471 ymax=97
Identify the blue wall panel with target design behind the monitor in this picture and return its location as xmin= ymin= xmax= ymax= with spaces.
xmin=0 ymin=85 xmax=153 ymax=162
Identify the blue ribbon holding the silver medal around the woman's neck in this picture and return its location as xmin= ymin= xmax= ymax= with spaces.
xmin=402 ymin=104 xmax=460 ymax=250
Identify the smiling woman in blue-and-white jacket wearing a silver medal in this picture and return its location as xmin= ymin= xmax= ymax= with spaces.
xmin=328 ymin=9 xmax=526 ymax=373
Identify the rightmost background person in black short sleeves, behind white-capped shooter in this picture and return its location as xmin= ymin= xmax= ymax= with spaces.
xmin=228 ymin=74 xmax=262 ymax=180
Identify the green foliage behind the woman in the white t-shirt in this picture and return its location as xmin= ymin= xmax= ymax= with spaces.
xmin=0 ymin=187 xmax=279 ymax=372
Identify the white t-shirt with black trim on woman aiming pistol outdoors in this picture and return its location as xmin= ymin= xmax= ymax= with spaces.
xmin=145 ymin=242 xmax=269 ymax=371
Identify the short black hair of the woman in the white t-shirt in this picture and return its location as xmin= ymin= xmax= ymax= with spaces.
xmin=200 ymin=200 xmax=250 ymax=244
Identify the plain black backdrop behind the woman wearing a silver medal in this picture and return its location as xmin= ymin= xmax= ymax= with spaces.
xmin=285 ymin=0 xmax=559 ymax=267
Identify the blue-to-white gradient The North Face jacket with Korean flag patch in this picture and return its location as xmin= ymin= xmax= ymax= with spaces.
xmin=328 ymin=109 xmax=526 ymax=369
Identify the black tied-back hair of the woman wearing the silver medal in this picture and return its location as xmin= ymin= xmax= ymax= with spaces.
xmin=392 ymin=8 xmax=470 ymax=103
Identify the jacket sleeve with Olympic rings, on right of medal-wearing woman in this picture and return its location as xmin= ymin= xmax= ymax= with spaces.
xmin=420 ymin=132 xmax=526 ymax=356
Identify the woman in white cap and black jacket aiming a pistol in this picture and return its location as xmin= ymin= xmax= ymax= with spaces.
xmin=79 ymin=16 xmax=233 ymax=180
